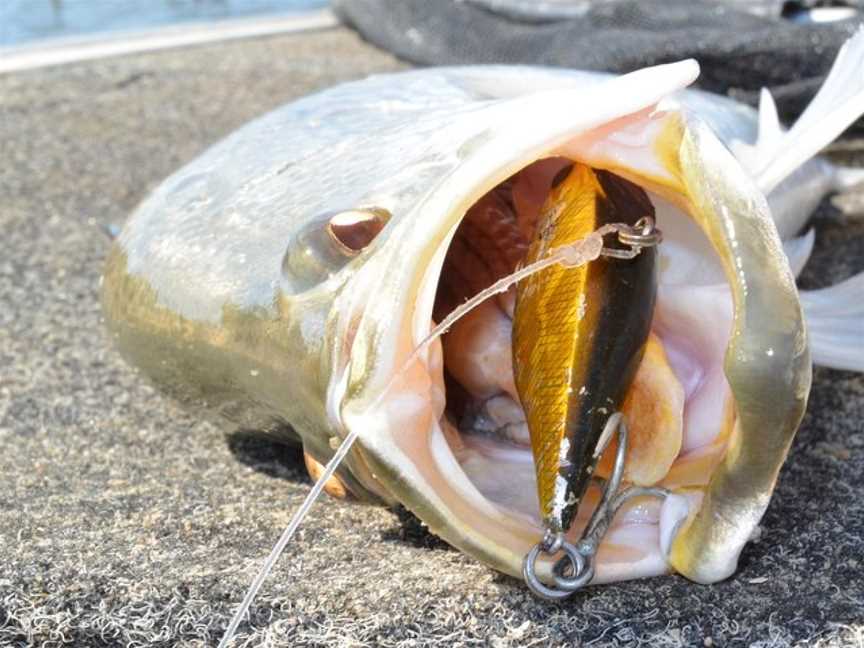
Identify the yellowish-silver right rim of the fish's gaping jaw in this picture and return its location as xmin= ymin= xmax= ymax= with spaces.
xmin=670 ymin=121 xmax=812 ymax=582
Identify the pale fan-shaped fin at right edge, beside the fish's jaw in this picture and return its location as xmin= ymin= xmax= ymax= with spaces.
xmin=800 ymin=272 xmax=864 ymax=371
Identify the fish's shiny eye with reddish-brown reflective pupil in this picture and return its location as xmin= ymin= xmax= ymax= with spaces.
xmin=282 ymin=207 xmax=390 ymax=295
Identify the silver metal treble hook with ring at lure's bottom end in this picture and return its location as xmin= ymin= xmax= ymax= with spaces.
xmin=522 ymin=412 xmax=669 ymax=601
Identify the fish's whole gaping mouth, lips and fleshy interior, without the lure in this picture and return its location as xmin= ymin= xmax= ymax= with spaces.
xmin=328 ymin=64 xmax=810 ymax=583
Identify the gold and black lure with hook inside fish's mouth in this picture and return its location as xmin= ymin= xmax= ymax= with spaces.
xmin=513 ymin=163 xmax=662 ymax=598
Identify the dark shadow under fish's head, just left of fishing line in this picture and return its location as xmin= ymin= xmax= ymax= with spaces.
xmin=226 ymin=430 xmax=310 ymax=484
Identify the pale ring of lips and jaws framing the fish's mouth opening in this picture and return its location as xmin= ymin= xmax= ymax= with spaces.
xmin=328 ymin=79 xmax=810 ymax=582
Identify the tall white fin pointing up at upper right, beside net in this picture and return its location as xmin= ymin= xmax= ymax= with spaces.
xmin=756 ymin=27 xmax=864 ymax=195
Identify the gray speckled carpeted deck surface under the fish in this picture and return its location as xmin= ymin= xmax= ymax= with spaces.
xmin=0 ymin=30 xmax=864 ymax=646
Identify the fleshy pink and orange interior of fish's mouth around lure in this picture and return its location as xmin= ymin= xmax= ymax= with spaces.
xmin=429 ymin=157 xmax=716 ymax=582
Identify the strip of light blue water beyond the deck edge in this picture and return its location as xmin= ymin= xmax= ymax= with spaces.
xmin=0 ymin=0 xmax=328 ymax=47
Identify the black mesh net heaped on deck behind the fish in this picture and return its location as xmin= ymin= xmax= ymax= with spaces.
xmin=334 ymin=0 xmax=864 ymax=126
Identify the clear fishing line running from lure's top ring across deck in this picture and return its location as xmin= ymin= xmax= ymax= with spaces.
xmin=218 ymin=223 xmax=632 ymax=648
